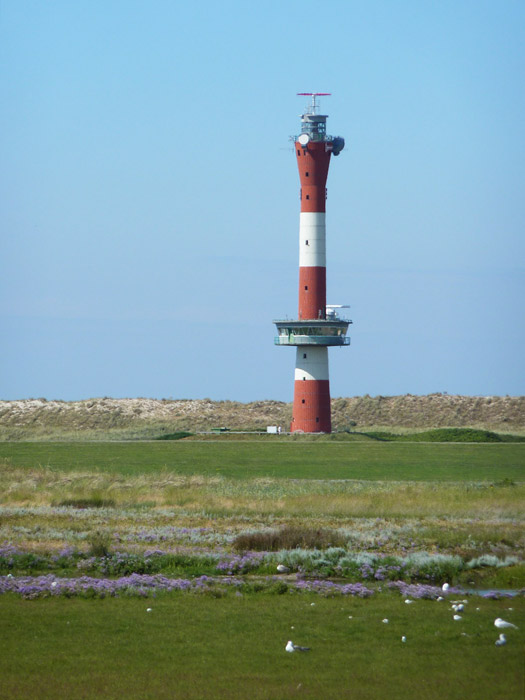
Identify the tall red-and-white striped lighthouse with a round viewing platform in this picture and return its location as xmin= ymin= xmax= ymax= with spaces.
xmin=274 ymin=92 xmax=351 ymax=433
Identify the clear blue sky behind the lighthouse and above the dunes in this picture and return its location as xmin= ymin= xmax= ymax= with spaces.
xmin=0 ymin=0 xmax=525 ymax=401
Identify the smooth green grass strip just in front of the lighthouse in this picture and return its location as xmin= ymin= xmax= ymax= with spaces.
xmin=0 ymin=439 xmax=525 ymax=481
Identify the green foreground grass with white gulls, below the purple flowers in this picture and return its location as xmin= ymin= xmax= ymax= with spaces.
xmin=0 ymin=593 xmax=525 ymax=700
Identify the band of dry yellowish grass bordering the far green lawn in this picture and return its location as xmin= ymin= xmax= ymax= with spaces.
xmin=0 ymin=466 xmax=525 ymax=520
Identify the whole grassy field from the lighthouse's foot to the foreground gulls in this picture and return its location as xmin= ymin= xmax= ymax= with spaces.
xmin=0 ymin=438 xmax=525 ymax=700
